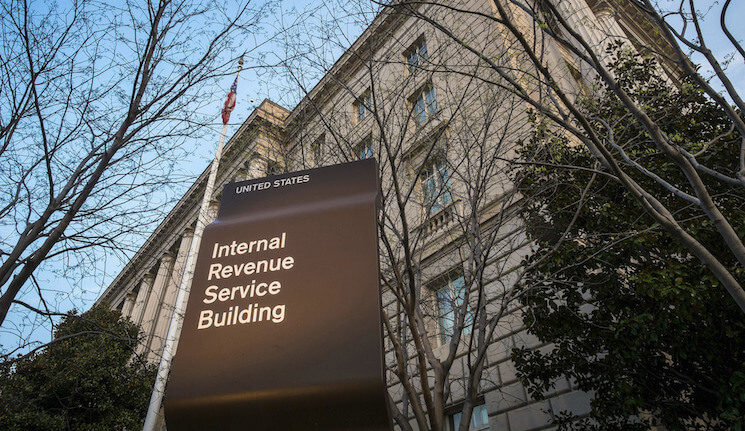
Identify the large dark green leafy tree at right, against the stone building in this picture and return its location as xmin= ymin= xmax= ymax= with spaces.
xmin=513 ymin=45 xmax=745 ymax=430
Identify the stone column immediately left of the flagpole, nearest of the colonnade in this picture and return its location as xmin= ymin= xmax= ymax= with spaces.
xmin=148 ymin=228 xmax=194 ymax=361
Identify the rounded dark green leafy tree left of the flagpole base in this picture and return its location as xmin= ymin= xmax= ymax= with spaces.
xmin=0 ymin=306 xmax=155 ymax=431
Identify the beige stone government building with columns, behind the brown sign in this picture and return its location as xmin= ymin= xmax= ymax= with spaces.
xmin=94 ymin=0 xmax=668 ymax=431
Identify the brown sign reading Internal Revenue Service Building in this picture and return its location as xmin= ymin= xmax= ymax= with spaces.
xmin=165 ymin=160 xmax=391 ymax=431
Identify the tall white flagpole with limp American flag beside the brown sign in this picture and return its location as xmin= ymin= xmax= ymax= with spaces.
xmin=142 ymin=57 xmax=243 ymax=431
